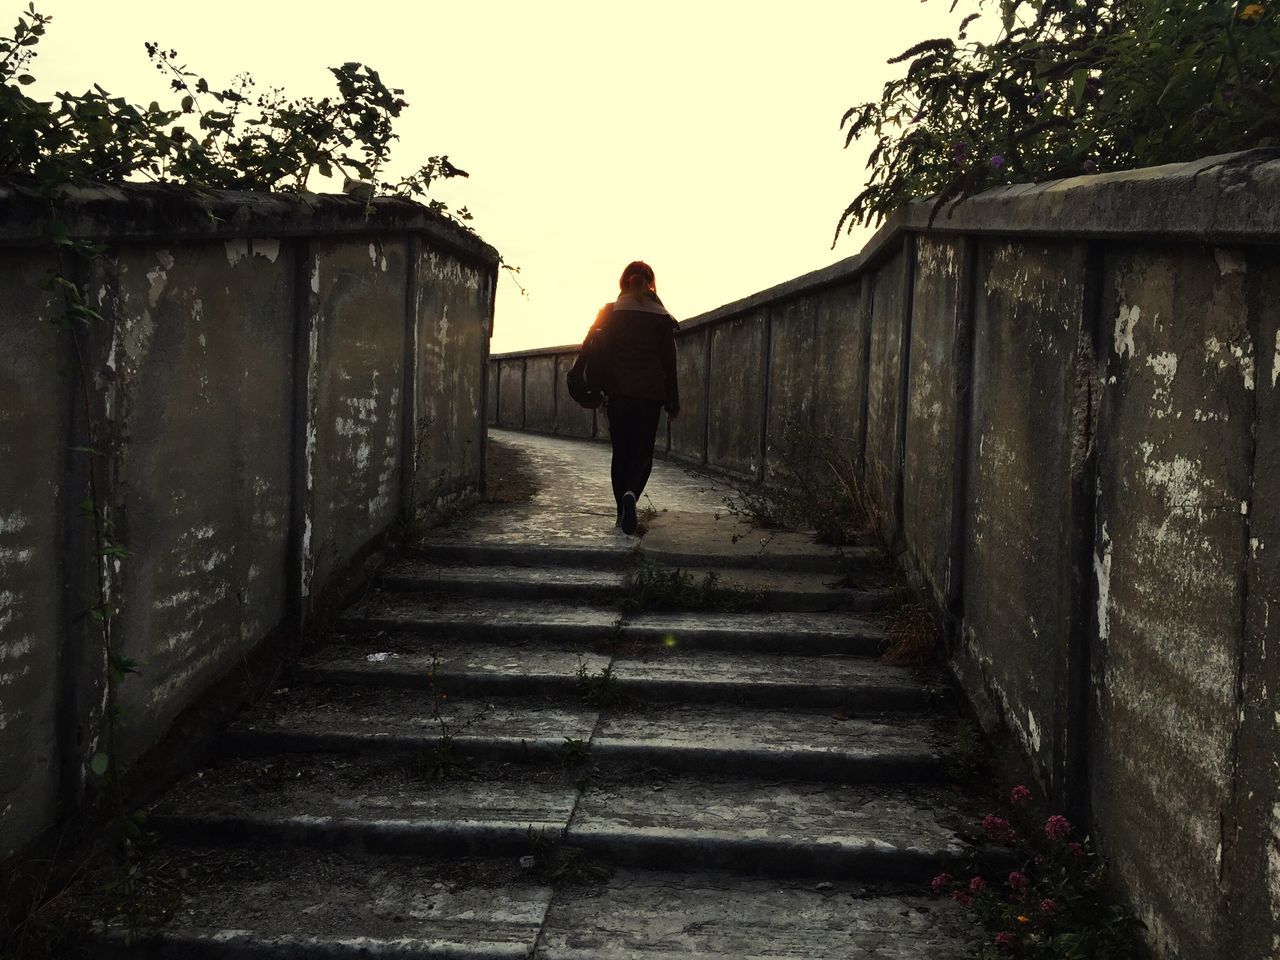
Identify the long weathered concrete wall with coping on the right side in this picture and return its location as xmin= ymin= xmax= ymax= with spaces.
xmin=499 ymin=151 xmax=1280 ymax=960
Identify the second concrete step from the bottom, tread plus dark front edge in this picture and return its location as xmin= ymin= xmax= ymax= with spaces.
xmin=151 ymin=753 xmax=969 ymax=883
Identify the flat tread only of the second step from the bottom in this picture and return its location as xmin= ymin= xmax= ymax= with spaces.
xmin=152 ymin=755 xmax=973 ymax=858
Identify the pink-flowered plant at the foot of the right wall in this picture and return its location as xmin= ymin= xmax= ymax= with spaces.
xmin=932 ymin=786 xmax=1147 ymax=960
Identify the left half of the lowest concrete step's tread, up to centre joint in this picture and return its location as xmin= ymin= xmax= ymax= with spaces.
xmin=87 ymin=845 xmax=553 ymax=960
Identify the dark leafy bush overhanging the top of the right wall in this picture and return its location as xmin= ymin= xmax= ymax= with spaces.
xmin=836 ymin=0 xmax=1280 ymax=231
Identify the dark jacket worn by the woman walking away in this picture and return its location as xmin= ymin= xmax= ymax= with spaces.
xmin=596 ymin=293 xmax=680 ymax=411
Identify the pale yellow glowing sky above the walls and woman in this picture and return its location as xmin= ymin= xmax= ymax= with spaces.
xmin=27 ymin=0 xmax=970 ymax=352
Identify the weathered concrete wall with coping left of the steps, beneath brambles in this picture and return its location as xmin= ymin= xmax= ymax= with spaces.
xmin=0 ymin=187 xmax=497 ymax=861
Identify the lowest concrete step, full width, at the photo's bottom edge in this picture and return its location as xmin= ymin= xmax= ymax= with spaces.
xmin=93 ymin=845 xmax=972 ymax=960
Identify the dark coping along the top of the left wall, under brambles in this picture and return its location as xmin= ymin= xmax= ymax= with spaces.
xmin=0 ymin=180 xmax=498 ymax=268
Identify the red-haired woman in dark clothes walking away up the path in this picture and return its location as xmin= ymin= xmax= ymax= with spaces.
xmin=596 ymin=260 xmax=680 ymax=535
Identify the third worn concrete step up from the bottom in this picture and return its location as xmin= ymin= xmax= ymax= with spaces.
xmin=224 ymin=686 xmax=951 ymax=783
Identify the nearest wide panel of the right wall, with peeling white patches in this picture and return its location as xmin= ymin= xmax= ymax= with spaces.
xmin=1092 ymin=241 xmax=1254 ymax=956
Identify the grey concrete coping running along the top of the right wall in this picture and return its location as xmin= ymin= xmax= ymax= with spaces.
xmin=490 ymin=148 xmax=1280 ymax=360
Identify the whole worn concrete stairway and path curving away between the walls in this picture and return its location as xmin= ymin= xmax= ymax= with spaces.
xmin=104 ymin=433 xmax=973 ymax=960
